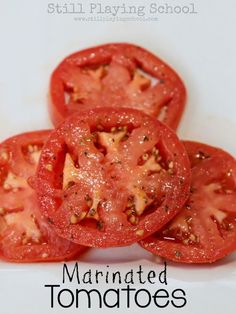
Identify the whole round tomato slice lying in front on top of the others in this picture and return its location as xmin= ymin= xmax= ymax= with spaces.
xmin=36 ymin=108 xmax=190 ymax=247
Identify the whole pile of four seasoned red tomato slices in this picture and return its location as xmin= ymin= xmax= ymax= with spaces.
xmin=0 ymin=44 xmax=236 ymax=263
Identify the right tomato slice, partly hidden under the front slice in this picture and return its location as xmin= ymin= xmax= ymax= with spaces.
xmin=141 ymin=142 xmax=236 ymax=263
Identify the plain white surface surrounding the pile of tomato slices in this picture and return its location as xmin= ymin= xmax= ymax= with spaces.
xmin=0 ymin=0 xmax=236 ymax=314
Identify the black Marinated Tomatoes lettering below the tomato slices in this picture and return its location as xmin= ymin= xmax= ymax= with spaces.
xmin=44 ymin=262 xmax=188 ymax=312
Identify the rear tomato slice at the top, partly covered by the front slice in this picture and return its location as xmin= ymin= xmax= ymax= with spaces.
xmin=50 ymin=43 xmax=186 ymax=129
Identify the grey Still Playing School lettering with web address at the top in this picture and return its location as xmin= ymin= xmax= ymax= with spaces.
xmin=47 ymin=1 xmax=198 ymax=22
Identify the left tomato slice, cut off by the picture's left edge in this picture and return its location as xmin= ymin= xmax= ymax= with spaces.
xmin=0 ymin=131 xmax=85 ymax=262
